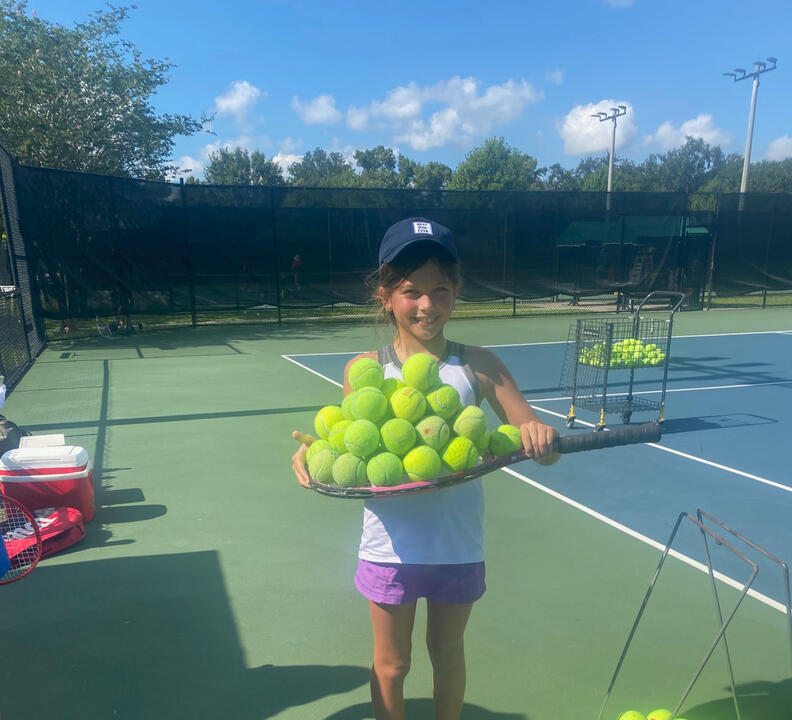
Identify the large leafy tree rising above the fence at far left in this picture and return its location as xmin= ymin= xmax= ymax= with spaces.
xmin=0 ymin=0 xmax=208 ymax=179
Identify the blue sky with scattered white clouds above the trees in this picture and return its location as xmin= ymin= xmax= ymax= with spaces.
xmin=27 ymin=0 xmax=792 ymax=178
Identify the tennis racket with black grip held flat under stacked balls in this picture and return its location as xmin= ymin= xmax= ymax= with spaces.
xmin=309 ymin=422 xmax=661 ymax=499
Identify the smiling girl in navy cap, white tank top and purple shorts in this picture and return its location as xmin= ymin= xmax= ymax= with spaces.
xmin=292 ymin=218 xmax=558 ymax=720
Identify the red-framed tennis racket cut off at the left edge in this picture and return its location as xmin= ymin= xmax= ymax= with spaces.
xmin=0 ymin=495 xmax=42 ymax=585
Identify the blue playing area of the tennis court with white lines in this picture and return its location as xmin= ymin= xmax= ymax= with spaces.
xmin=284 ymin=332 xmax=792 ymax=611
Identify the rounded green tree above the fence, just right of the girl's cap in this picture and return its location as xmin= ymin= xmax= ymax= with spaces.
xmin=448 ymin=137 xmax=545 ymax=190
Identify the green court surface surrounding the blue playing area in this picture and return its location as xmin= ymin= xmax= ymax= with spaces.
xmin=0 ymin=309 xmax=792 ymax=720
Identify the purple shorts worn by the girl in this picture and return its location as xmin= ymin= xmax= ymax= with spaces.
xmin=355 ymin=559 xmax=487 ymax=605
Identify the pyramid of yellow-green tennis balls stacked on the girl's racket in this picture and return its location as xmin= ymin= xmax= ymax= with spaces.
xmin=306 ymin=353 xmax=522 ymax=487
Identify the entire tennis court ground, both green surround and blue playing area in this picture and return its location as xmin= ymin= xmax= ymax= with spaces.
xmin=0 ymin=309 xmax=792 ymax=720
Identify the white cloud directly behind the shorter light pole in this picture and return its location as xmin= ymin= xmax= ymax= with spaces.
xmin=558 ymin=100 xmax=638 ymax=155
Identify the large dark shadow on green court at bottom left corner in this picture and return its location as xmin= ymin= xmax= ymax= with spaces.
xmin=0 ymin=552 xmax=369 ymax=720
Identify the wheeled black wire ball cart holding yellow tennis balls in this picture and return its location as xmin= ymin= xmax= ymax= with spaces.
xmin=561 ymin=290 xmax=686 ymax=430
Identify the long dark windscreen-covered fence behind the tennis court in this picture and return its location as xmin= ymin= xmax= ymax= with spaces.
xmin=0 ymin=141 xmax=792 ymax=352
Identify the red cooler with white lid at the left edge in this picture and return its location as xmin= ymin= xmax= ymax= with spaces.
xmin=0 ymin=445 xmax=94 ymax=522
